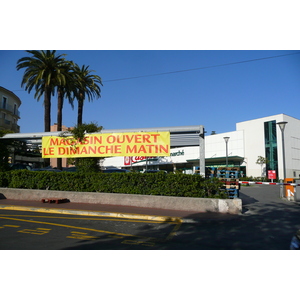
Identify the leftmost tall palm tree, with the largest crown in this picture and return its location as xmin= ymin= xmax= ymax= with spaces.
xmin=17 ymin=50 xmax=66 ymax=132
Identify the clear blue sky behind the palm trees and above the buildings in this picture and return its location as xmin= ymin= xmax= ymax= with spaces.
xmin=0 ymin=50 xmax=300 ymax=134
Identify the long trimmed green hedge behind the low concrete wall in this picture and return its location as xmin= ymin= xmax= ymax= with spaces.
xmin=0 ymin=170 xmax=228 ymax=198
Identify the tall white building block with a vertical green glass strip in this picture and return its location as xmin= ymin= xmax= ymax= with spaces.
xmin=236 ymin=114 xmax=300 ymax=179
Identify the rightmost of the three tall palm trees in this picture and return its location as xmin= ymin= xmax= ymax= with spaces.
xmin=74 ymin=64 xmax=103 ymax=126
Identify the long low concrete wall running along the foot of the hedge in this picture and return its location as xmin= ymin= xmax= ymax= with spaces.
xmin=0 ymin=188 xmax=242 ymax=214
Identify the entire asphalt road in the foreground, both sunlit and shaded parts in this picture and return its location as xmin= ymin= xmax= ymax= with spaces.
xmin=0 ymin=186 xmax=300 ymax=250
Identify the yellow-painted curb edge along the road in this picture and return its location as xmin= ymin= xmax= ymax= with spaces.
xmin=0 ymin=205 xmax=184 ymax=223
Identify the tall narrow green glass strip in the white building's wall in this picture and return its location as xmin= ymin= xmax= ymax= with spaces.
xmin=264 ymin=120 xmax=278 ymax=175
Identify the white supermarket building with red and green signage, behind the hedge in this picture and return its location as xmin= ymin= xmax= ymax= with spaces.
xmin=103 ymin=114 xmax=300 ymax=179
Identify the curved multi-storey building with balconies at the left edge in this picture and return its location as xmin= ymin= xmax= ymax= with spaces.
xmin=0 ymin=86 xmax=21 ymax=133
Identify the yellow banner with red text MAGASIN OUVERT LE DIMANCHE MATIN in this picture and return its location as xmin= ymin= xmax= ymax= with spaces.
xmin=42 ymin=131 xmax=170 ymax=158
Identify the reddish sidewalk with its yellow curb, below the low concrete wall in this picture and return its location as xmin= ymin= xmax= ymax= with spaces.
xmin=0 ymin=199 xmax=238 ymax=223
